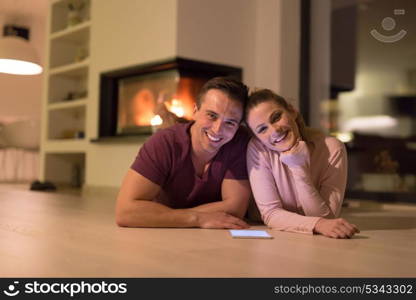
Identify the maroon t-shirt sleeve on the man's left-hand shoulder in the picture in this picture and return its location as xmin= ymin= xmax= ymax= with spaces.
xmin=131 ymin=130 xmax=173 ymax=186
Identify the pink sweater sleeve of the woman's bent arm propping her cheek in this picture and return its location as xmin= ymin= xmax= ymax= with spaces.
xmin=291 ymin=141 xmax=347 ymax=218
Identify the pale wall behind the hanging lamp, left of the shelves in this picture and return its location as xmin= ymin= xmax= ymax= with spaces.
xmin=0 ymin=0 xmax=48 ymax=122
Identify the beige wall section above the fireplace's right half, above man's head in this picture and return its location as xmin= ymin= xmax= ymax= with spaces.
xmin=177 ymin=0 xmax=256 ymax=85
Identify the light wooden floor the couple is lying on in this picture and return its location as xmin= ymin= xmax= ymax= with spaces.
xmin=0 ymin=185 xmax=416 ymax=277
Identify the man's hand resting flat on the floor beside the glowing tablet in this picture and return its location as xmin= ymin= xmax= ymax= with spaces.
xmin=197 ymin=212 xmax=250 ymax=229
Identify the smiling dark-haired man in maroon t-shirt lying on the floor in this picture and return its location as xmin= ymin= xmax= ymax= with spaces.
xmin=116 ymin=77 xmax=251 ymax=229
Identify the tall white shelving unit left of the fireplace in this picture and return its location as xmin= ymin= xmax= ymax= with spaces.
xmin=40 ymin=0 xmax=93 ymax=188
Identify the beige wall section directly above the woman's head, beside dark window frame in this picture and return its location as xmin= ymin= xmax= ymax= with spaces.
xmin=253 ymin=0 xmax=300 ymax=103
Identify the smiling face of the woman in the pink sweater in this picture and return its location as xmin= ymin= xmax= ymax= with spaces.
xmin=247 ymin=100 xmax=300 ymax=152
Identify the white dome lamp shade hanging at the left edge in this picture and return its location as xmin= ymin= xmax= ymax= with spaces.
xmin=0 ymin=36 xmax=42 ymax=75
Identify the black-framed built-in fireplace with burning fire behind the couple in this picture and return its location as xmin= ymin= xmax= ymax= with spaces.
xmin=99 ymin=58 xmax=242 ymax=139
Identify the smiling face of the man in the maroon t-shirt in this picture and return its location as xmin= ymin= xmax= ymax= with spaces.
xmin=191 ymin=89 xmax=243 ymax=154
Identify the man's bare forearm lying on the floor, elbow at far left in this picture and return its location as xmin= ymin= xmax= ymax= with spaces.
xmin=116 ymin=200 xmax=198 ymax=228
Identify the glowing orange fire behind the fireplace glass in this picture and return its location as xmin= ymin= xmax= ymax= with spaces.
xmin=117 ymin=70 xmax=206 ymax=134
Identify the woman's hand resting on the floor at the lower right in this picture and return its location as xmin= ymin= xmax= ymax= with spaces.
xmin=313 ymin=218 xmax=360 ymax=239
